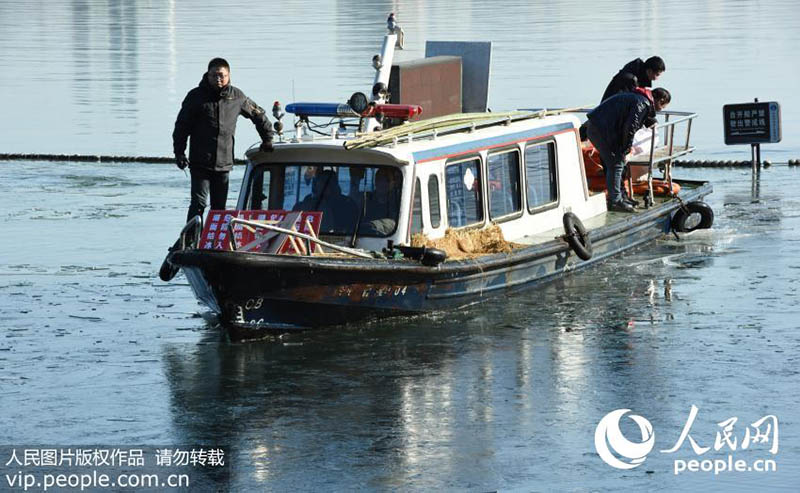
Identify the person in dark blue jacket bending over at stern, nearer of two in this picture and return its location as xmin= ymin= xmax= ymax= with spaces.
xmin=586 ymin=87 xmax=672 ymax=212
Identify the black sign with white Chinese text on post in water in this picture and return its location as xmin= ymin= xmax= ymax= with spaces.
xmin=722 ymin=98 xmax=781 ymax=198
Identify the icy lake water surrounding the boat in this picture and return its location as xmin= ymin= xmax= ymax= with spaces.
xmin=0 ymin=0 xmax=800 ymax=491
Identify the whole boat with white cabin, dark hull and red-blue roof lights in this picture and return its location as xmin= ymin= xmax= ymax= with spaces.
xmin=162 ymin=27 xmax=713 ymax=341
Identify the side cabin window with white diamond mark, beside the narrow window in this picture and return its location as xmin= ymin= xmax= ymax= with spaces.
xmin=445 ymin=159 xmax=483 ymax=228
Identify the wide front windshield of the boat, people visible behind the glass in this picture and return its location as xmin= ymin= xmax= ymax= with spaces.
xmin=246 ymin=164 xmax=403 ymax=237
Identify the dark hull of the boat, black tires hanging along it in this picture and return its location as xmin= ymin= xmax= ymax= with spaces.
xmin=170 ymin=183 xmax=711 ymax=340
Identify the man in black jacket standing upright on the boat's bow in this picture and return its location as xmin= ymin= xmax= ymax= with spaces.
xmin=172 ymin=58 xmax=273 ymax=221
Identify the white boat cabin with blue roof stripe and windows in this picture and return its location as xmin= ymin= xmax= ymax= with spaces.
xmin=237 ymin=113 xmax=606 ymax=251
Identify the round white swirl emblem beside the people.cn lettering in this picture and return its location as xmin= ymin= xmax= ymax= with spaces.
xmin=594 ymin=409 xmax=656 ymax=469
